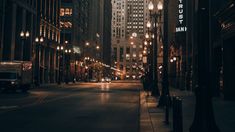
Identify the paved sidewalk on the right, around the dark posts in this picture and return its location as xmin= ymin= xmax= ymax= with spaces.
xmin=140 ymin=88 xmax=235 ymax=132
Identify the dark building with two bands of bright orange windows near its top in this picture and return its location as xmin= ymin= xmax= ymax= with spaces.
xmin=60 ymin=0 xmax=81 ymax=83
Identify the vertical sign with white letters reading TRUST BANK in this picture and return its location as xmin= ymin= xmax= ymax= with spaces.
xmin=176 ymin=0 xmax=187 ymax=32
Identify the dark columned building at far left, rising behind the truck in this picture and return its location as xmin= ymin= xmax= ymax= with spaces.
xmin=0 ymin=0 xmax=36 ymax=61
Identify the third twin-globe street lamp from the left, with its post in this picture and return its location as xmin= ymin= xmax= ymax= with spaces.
xmin=57 ymin=46 xmax=64 ymax=85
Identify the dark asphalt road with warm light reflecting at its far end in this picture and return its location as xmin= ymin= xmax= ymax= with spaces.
xmin=0 ymin=82 xmax=141 ymax=132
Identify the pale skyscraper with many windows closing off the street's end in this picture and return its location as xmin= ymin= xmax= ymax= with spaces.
xmin=112 ymin=0 xmax=149 ymax=79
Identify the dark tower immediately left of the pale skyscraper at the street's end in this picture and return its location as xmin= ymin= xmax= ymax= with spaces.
xmin=84 ymin=0 xmax=112 ymax=79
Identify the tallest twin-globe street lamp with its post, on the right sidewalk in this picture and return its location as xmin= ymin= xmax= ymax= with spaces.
xmin=148 ymin=1 xmax=162 ymax=96
